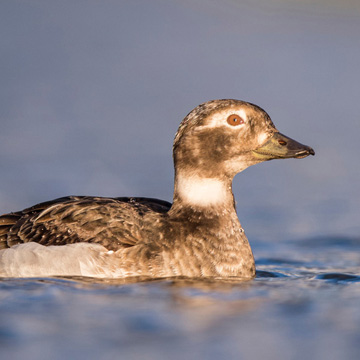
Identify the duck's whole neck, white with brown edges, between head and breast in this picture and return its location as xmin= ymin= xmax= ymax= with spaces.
xmin=172 ymin=173 xmax=235 ymax=213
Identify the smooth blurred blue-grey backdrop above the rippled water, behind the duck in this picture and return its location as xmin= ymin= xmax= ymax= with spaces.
xmin=0 ymin=0 xmax=360 ymax=242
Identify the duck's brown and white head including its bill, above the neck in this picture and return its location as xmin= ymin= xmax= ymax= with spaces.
xmin=173 ymin=100 xmax=315 ymax=180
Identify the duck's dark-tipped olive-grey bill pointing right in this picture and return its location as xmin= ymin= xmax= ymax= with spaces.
xmin=253 ymin=132 xmax=315 ymax=160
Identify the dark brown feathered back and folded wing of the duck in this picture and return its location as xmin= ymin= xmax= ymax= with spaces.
xmin=0 ymin=196 xmax=171 ymax=251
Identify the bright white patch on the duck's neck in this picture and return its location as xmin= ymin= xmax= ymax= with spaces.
xmin=176 ymin=176 xmax=228 ymax=207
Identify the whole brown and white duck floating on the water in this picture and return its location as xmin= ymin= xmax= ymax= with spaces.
xmin=0 ymin=100 xmax=313 ymax=278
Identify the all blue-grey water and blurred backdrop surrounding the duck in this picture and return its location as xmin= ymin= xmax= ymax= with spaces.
xmin=0 ymin=0 xmax=360 ymax=360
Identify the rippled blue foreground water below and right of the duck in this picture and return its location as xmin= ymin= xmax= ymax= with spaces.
xmin=0 ymin=238 xmax=360 ymax=359
